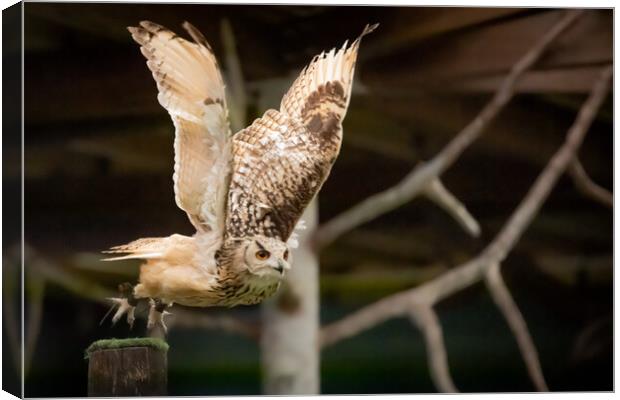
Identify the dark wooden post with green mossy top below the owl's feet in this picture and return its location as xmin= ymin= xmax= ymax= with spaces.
xmin=86 ymin=338 xmax=168 ymax=397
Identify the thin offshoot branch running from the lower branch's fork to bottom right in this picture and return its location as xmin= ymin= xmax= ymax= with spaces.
xmin=485 ymin=263 xmax=549 ymax=392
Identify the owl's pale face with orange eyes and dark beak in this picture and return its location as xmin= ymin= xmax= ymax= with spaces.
xmin=244 ymin=235 xmax=291 ymax=279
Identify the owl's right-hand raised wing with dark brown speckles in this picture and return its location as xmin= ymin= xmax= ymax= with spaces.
xmin=226 ymin=25 xmax=376 ymax=241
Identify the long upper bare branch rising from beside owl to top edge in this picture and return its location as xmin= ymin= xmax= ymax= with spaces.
xmin=314 ymin=10 xmax=583 ymax=249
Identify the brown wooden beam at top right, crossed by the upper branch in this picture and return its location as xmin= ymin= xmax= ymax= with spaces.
xmin=362 ymin=10 xmax=613 ymax=87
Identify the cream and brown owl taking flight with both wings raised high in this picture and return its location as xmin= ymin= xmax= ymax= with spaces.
xmin=106 ymin=21 xmax=377 ymax=330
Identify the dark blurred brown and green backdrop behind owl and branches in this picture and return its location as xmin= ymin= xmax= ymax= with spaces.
xmin=3 ymin=3 xmax=613 ymax=397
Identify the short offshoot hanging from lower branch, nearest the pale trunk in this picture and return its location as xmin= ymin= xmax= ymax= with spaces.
xmin=409 ymin=307 xmax=459 ymax=393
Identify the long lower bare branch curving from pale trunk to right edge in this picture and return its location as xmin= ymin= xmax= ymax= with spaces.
xmin=321 ymin=66 xmax=613 ymax=346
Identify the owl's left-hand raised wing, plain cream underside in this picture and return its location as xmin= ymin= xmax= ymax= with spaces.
xmin=127 ymin=21 xmax=232 ymax=231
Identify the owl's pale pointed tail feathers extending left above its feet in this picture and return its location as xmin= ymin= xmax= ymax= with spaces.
xmin=101 ymin=235 xmax=194 ymax=261
